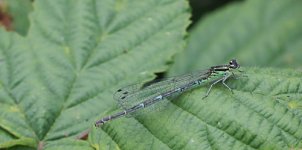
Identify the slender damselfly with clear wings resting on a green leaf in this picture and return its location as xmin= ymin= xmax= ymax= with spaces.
xmin=95 ymin=59 xmax=240 ymax=126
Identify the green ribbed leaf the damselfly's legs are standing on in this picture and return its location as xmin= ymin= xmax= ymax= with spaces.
xmin=89 ymin=68 xmax=302 ymax=149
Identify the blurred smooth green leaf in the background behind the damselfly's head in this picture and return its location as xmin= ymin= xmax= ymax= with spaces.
xmin=169 ymin=0 xmax=302 ymax=75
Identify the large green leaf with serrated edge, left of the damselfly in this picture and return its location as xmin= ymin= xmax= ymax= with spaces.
xmin=0 ymin=0 xmax=189 ymax=149
